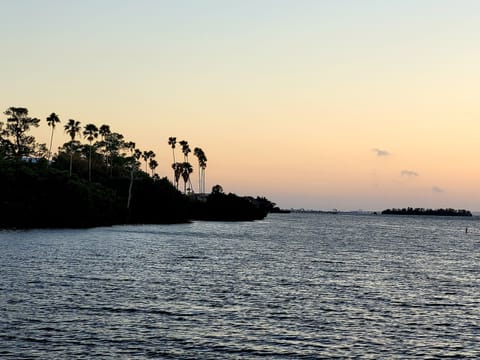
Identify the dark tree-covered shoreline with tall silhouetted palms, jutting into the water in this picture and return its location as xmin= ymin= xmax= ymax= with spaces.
xmin=0 ymin=107 xmax=273 ymax=228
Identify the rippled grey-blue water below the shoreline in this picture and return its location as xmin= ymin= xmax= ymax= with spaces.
xmin=0 ymin=214 xmax=480 ymax=359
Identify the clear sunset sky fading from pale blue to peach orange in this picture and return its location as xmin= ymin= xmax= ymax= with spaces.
xmin=0 ymin=0 xmax=480 ymax=211
